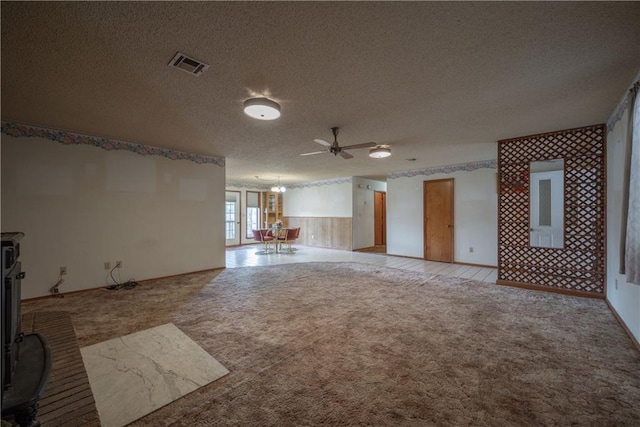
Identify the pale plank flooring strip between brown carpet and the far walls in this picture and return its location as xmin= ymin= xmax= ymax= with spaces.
xmin=226 ymin=245 xmax=498 ymax=283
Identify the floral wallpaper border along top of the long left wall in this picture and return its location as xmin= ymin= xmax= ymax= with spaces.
xmin=0 ymin=121 xmax=225 ymax=167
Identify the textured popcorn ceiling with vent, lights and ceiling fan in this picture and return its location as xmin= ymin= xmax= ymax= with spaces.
xmin=1 ymin=2 xmax=640 ymax=183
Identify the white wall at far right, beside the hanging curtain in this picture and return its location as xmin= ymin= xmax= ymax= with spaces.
xmin=607 ymin=108 xmax=640 ymax=341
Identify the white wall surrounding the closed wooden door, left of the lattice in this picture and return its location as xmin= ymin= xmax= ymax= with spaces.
xmin=387 ymin=168 xmax=498 ymax=266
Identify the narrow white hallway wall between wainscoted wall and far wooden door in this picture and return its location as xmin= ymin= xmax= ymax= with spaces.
xmin=352 ymin=177 xmax=387 ymax=249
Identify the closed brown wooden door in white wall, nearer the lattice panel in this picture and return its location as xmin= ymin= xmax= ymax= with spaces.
xmin=424 ymin=179 xmax=453 ymax=262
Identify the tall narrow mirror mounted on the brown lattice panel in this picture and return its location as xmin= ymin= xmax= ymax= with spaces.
xmin=529 ymin=159 xmax=564 ymax=248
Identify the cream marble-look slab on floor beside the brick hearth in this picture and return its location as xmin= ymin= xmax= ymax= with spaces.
xmin=80 ymin=323 xmax=229 ymax=427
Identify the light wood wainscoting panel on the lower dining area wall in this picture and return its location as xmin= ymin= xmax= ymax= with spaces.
xmin=284 ymin=216 xmax=353 ymax=251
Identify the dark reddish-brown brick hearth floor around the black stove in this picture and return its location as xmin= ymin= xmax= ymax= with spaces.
xmin=22 ymin=312 xmax=100 ymax=427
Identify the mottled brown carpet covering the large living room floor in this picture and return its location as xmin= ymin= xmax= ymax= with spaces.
xmin=23 ymin=263 xmax=640 ymax=426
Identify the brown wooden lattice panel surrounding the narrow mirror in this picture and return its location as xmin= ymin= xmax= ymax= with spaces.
xmin=497 ymin=125 xmax=606 ymax=297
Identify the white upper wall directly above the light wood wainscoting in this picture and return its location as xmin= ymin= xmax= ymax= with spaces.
xmin=282 ymin=182 xmax=353 ymax=218
